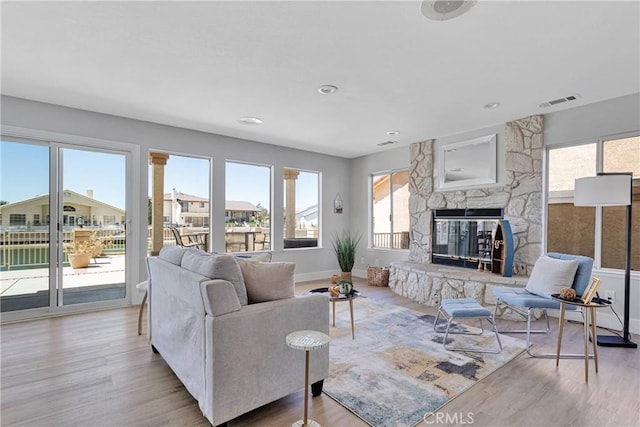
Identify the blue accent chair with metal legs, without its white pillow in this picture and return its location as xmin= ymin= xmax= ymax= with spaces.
xmin=493 ymin=252 xmax=593 ymax=358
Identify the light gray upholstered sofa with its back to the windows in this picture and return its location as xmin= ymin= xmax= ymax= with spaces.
xmin=147 ymin=247 xmax=329 ymax=426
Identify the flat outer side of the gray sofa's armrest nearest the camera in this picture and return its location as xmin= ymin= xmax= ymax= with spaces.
xmin=204 ymin=294 xmax=330 ymax=425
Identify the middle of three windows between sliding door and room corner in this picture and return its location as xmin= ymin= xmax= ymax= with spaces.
xmin=225 ymin=161 xmax=271 ymax=252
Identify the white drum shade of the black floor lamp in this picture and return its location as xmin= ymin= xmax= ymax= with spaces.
xmin=573 ymin=174 xmax=631 ymax=206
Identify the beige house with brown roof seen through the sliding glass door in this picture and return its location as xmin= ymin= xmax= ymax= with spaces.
xmin=0 ymin=189 xmax=125 ymax=230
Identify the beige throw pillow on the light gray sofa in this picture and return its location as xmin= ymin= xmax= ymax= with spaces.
xmin=236 ymin=258 xmax=296 ymax=304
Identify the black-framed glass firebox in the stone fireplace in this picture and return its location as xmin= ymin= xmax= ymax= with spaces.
xmin=431 ymin=208 xmax=503 ymax=268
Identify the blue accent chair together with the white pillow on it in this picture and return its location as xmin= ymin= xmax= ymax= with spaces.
xmin=493 ymin=252 xmax=593 ymax=358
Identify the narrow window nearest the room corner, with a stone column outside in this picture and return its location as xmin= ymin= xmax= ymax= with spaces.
xmin=283 ymin=168 xmax=320 ymax=249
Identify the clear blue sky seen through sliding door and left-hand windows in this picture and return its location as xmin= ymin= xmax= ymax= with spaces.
xmin=0 ymin=141 xmax=318 ymax=210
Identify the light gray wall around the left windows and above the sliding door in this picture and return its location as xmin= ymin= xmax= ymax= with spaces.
xmin=1 ymin=96 xmax=355 ymax=290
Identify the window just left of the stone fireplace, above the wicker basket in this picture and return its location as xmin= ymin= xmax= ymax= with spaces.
xmin=371 ymin=170 xmax=409 ymax=249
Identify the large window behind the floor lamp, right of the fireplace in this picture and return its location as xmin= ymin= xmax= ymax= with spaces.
xmin=547 ymin=136 xmax=640 ymax=270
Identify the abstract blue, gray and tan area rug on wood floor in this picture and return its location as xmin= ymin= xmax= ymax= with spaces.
xmin=324 ymin=297 xmax=525 ymax=427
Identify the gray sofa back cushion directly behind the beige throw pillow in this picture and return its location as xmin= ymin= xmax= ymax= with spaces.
xmin=181 ymin=248 xmax=248 ymax=305
